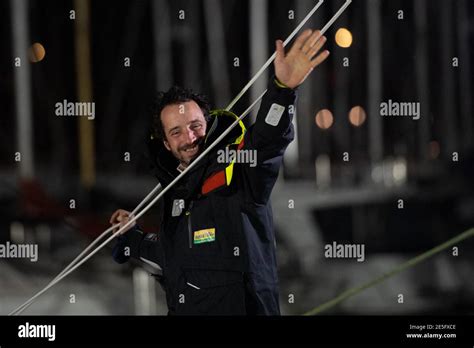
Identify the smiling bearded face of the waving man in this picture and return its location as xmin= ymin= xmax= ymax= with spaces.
xmin=161 ymin=101 xmax=207 ymax=165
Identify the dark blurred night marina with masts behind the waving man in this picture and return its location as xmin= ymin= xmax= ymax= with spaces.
xmin=0 ymin=0 xmax=474 ymax=314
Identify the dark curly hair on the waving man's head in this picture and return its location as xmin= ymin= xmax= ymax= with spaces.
xmin=151 ymin=86 xmax=211 ymax=140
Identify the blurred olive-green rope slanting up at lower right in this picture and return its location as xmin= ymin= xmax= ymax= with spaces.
xmin=303 ymin=228 xmax=474 ymax=315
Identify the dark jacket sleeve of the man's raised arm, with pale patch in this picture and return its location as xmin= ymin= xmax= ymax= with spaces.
xmin=242 ymin=76 xmax=297 ymax=204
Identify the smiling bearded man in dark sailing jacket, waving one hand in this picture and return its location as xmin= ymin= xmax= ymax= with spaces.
xmin=110 ymin=30 xmax=329 ymax=315
